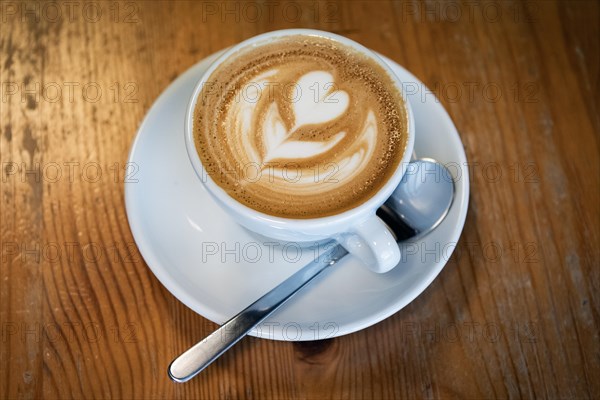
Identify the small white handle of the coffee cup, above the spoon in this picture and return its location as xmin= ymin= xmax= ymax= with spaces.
xmin=336 ymin=215 xmax=400 ymax=273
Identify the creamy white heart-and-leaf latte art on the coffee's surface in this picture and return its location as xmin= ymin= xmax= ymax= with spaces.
xmin=223 ymin=70 xmax=377 ymax=193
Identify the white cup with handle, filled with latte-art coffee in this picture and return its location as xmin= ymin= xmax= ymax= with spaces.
xmin=185 ymin=29 xmax=415 ymax=273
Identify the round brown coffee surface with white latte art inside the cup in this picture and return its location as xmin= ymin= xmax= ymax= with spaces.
xmin=193 ymin=35 xmax=408 ymax=218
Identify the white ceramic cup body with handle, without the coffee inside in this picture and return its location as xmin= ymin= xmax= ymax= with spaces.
xmin=185 ymin=29 xmax=415 ymax=273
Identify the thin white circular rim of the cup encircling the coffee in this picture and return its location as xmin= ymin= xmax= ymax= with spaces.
xmin=184 ymin=29 xmax=415 ymax=229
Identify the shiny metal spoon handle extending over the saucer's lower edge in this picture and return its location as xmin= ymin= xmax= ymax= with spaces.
xmin=168 ymin=242 xmax=348 ymax=382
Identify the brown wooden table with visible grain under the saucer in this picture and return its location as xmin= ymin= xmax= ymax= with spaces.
xmin=0 ymin=0 xmax=600 ymax=399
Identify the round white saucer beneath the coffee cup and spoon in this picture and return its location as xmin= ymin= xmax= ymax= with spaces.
xmin=125 ymin=50 xmax=469 ymax=340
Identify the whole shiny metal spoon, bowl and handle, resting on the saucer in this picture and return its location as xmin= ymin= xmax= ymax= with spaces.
xmin=168 ymin=159 xmax=454 ymax=382
